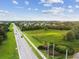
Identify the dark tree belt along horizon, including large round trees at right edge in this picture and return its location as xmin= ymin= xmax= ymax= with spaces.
xmin=16 ymin=21 xmax=79 ymax=41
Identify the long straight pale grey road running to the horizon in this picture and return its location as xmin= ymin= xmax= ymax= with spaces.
xmin=14 ymin=25 xmax=38 ymax=59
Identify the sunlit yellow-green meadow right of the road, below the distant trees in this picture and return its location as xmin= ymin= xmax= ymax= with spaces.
xmin=24 ymin=30 xmax=67 ymax=47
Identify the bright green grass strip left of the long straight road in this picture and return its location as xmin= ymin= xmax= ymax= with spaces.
xmin=0 ymin=24 xmax=19 ymax=59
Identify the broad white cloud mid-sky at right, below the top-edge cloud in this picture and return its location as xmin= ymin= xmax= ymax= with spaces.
xmin=42 ymin=7 xmax=74 ymax=16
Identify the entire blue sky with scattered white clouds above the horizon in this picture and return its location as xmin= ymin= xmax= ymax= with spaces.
xmin=0 ymin=0 xmax=79 ymax=21
